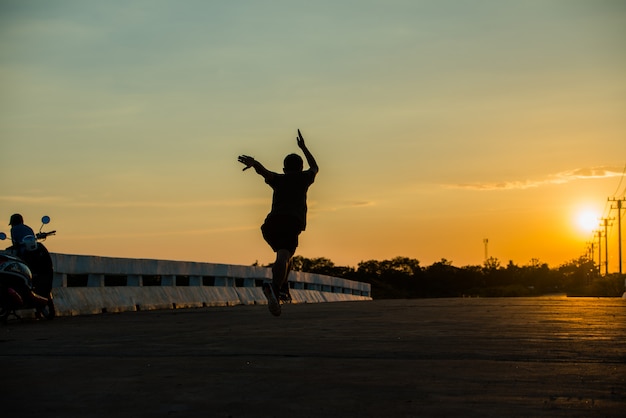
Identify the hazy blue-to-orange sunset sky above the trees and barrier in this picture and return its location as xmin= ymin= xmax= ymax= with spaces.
xmin=0 ymin=0 xmax=626 ymax=271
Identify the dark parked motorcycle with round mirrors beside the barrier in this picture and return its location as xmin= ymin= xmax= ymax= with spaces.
xmin=0 ymin=216 xmax=56 ymax=323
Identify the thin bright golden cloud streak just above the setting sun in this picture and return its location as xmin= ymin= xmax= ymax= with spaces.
xmin=445 ymin=166 xmax=625 ymax=191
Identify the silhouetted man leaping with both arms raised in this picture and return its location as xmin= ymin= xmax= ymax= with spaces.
xmin=238 ymin=129 xmax=319 ymax=316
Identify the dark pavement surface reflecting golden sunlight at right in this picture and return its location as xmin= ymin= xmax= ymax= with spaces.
xmin=0 ymin=297 xmax=626 ymax=418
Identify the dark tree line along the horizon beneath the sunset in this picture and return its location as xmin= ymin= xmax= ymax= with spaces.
xmin=270 ymin=256 xmax=625 ymax=299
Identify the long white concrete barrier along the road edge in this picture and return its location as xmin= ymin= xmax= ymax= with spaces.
xmin=51 ymin=253 xmax=372 ymax=315
